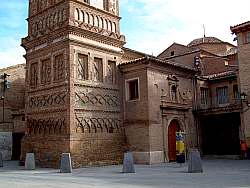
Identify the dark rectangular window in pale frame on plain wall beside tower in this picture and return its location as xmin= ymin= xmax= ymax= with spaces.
xmin=126 ymin=78 xmax=139 ymax=101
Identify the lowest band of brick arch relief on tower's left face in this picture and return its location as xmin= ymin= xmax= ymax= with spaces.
xmin=27 ymin=118 xmax=66 ymax=135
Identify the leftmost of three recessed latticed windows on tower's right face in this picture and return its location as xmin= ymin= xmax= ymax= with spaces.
xmin=76 ymin=54 xmax=88 ymax=80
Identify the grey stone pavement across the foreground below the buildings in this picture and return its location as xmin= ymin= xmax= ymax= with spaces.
xmin=0 ymin=160 xmax=250 ymax=188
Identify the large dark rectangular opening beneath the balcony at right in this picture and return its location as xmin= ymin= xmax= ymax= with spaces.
xmin=200 ymin=113 xmax=241 ymax=155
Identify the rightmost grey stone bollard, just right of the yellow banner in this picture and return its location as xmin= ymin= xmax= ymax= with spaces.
xmin=188 ymin=149 xmax=203 ymax=173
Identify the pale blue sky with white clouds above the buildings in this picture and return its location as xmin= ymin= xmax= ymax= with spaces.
xmin=0 ymin=0 xmax=250 ymax=68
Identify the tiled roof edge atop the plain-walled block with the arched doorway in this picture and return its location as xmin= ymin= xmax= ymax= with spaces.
xmin=120 ymin=56 xmax=197 ymax=71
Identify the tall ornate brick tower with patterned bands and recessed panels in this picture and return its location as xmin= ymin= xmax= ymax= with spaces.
xmin=22 ymin=0 xmax=125 ymax=167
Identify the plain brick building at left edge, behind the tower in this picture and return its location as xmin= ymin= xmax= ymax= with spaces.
xmin=0 ymin=64 xmax=25 ymax=160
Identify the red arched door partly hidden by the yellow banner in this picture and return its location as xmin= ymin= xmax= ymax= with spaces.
xmin=168 ymin=120 xmax=181 ymax=161
